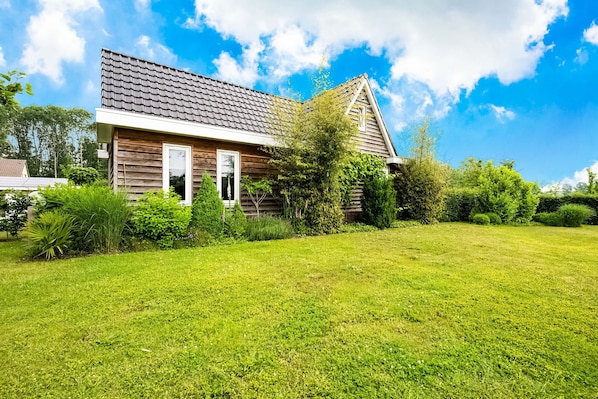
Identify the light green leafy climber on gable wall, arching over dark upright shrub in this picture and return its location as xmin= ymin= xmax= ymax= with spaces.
xmin=339 ymin=152 xmax=385 ymax=205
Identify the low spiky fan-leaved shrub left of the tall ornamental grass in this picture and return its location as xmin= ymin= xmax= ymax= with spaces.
xmin=25 ymin=211 xmax=73 ymax=259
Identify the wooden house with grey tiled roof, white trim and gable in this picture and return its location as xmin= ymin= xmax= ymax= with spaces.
xmin=96 ymin=49 xmax=401 ymax=219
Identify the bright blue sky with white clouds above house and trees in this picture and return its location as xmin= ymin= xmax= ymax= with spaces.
xmin=0 ymin=0 xmax=598 ymax=185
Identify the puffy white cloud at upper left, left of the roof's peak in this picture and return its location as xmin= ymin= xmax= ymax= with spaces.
xmin=21 ymin=0 xmax=102 ymax=84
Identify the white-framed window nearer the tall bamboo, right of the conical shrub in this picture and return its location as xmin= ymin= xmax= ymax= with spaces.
xmin=216 ymin=150 xmax=241 ymax=208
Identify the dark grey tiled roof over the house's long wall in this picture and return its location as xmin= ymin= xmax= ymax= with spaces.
xmin=102 ymin=49 xmax=298 ymax=134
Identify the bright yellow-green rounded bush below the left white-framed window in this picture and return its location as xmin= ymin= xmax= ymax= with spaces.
xmin=133 ymin=188 xmax=191 ymax=248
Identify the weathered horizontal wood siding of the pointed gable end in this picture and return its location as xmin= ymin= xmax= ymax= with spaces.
xmin=349 ymin=90 xmax=390 ymax=159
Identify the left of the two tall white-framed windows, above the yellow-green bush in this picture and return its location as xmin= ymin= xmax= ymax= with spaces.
xmin=162 ymin=144 xmax=193 ymax=205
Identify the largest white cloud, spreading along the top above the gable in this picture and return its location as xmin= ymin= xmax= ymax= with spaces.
xmin=190 ymin=0 xmax=568 ymax=120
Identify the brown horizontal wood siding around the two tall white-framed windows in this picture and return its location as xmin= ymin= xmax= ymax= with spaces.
xmin=115 ymin=129 xmax=282 ymax=216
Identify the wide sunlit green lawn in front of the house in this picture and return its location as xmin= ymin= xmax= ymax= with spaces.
xmin=0 ymin=224 xmax=598 ymax=398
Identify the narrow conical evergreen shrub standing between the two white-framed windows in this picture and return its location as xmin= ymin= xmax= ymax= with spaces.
xmin=191 ymin=173 xmax=224 ymax=239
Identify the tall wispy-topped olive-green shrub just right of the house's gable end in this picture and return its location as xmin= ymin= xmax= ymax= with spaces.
xmin=395 ymin=119 xmax=449 ymax=223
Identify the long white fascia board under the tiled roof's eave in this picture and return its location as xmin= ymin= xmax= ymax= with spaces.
xmin=96 ymin=108 xmax=276 ymax=145
